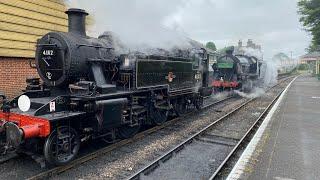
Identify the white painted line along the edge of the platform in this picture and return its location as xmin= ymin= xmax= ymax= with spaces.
xmin=227 ymin=77 xmax=298 ymax=180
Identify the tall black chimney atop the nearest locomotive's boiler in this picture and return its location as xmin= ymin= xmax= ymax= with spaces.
xmin=66 ymin=8 xmax=88 ymax=36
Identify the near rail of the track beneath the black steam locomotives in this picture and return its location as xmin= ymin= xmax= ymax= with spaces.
xmin=27 ymin=96 xmax=235 ymax=180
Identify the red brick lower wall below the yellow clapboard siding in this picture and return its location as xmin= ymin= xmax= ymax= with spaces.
xmin=0 ymin=57 xmax=38 ymax=98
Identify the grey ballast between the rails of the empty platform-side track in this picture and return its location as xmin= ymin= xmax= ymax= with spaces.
xmin=135 ymin=78 xmax=292 ymax=179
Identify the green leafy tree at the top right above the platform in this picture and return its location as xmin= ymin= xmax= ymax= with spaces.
xmin=298 ymin=0 xmax=320 ymax=52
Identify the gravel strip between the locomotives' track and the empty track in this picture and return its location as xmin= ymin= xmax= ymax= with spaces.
xmin=53 ymin=99 xmax=244 ymax=179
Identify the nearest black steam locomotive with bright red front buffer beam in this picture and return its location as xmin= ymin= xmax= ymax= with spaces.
xmin=0 ymin=9 xmax=212 ymax=165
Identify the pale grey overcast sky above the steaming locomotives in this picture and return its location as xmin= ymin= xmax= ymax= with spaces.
xmin=67 ymin=0 xmax=310 ymax=58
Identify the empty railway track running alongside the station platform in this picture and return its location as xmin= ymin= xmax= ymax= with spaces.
xmin=128 ymin=77 xmax=291 ymax=179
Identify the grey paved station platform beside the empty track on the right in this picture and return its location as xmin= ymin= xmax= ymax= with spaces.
xmin=228 ymin=75 xmax=320 ymax=180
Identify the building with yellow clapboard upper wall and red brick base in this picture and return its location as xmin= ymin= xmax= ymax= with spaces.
xmin=0 ymin=0 xmax=68 ymax=97
